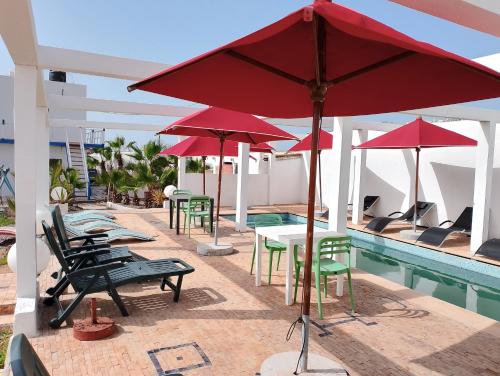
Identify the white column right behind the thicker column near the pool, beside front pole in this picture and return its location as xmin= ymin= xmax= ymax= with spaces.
xmin=352 ymin=130 xmax=368 ymax=225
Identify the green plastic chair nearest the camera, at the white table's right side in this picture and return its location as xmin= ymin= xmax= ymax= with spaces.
xmin=293 ymin=236 xmax=356 ymax=320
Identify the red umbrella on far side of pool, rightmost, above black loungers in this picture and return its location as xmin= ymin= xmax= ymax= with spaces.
xmin=356 ymin=117 xmax=477 ymax=231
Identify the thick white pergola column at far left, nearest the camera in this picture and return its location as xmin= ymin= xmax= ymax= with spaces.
xmin=14 ymin=65 xmax=38 ymax=336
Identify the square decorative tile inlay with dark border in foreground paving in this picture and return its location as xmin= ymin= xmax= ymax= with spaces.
xmin=147 ymin=342 xmax=212 ymax=376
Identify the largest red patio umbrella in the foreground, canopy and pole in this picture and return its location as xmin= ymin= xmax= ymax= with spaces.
xmin=128 ymin=0 xmax=500 ymax=369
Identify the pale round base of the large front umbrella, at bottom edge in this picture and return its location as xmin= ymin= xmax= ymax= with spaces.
xmin=260 ymin=351 xmax=347 ymax=376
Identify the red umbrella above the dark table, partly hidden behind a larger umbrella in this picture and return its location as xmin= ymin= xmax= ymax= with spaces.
xmin=160 ymin=136 xmax=273 ymax=194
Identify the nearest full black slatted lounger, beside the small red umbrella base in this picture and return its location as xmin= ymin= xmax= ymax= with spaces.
xmin=42 ymin=221 xmax=194 ymax=329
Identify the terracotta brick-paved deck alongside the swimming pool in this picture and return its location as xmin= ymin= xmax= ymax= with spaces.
xmin=14 ymin=207 xmax=500 ymax=376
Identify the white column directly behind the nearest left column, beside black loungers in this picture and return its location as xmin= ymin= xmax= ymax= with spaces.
xmin=36 ymin=107 xmax=52 ymax=234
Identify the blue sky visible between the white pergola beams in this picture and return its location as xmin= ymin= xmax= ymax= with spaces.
xmin=0 ymin=0 xmax=500 ymax=147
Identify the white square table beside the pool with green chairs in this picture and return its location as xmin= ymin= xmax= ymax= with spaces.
xmin=255 ymin=224 xmax=346 ymax=305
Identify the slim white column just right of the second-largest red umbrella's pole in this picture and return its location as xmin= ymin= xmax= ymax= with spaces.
xmin=236 ymin=142 xmax=250 ymax=231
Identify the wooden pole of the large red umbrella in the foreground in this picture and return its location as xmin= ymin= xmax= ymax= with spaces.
xmin=299 ymin=7 xmax=328 ymax=372
